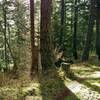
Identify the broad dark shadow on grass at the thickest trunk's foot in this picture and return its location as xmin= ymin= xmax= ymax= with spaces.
xmin=39 ymin=70 xmax=79 ymax=100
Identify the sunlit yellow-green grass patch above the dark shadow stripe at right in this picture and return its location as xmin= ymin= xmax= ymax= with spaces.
xmin=71 ymin=64 xmax=100 ymax=78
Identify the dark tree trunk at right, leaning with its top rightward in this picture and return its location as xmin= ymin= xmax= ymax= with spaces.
xmin=82 ymin=0 xmax=95 ymax=61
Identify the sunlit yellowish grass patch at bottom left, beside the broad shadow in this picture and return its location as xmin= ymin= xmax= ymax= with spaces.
xmin=0 ymin=82 xmax=42 ymax=100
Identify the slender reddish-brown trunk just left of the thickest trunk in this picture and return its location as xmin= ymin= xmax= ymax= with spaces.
xmin=30 ymin=0 xmax=38 ymax=77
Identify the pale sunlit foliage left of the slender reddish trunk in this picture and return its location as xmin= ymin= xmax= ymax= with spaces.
xmin=0 ymin=0 xmax=28 ymax=70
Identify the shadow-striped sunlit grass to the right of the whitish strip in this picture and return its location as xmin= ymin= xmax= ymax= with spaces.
xmin=71 ymin=60 xmax=100 ymax=93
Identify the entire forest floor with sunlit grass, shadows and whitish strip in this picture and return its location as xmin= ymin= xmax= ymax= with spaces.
xmin=0 ymin=58 xmax=100 ymax=100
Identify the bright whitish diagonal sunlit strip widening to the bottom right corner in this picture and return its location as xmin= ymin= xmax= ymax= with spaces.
xmin=58 ymin=71 xmax=100 ymax=100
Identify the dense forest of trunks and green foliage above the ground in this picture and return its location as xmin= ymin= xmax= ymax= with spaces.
xmin=0 ymin=0 xmax=100 ymax=100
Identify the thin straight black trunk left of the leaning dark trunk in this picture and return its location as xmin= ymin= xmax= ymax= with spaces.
xmin=73 ymin=0 xmax=78 ymax=60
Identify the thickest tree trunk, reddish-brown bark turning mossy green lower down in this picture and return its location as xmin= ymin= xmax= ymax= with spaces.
xmin=40 ymin=0 xmax=53 ymax=70
